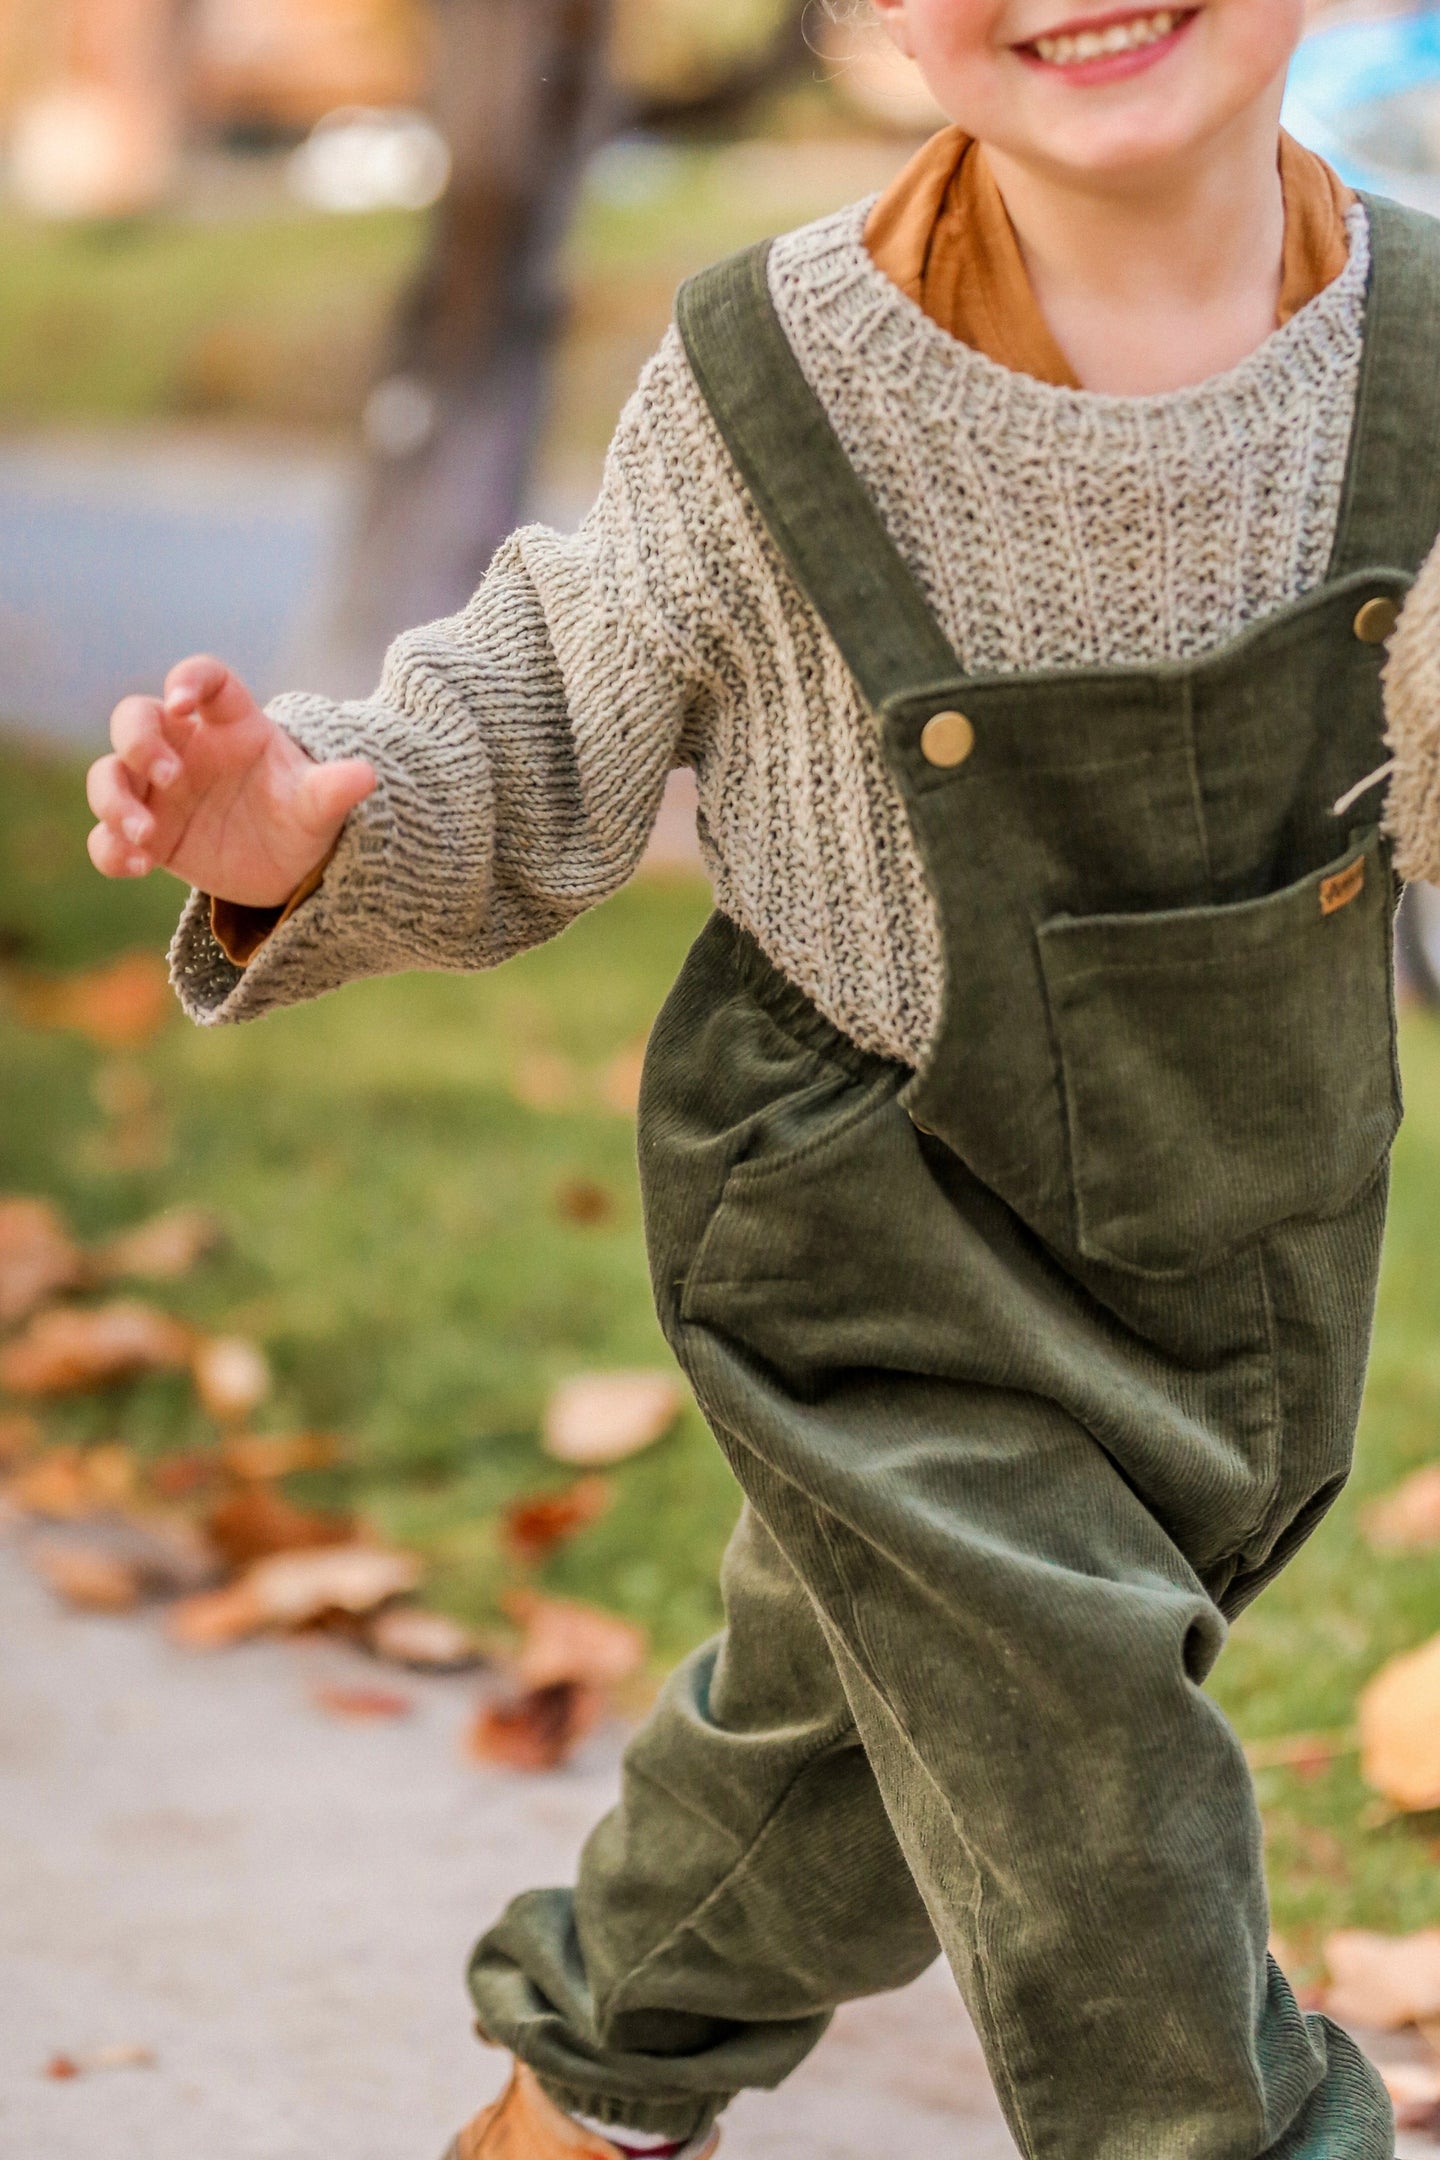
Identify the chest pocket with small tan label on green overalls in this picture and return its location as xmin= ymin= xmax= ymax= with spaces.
xmin=1038 ymin=832 xmax=1401 ymax=1274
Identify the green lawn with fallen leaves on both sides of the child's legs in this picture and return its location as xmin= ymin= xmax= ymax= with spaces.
xmin=0 ymin=750 xmax=1440 ymax=1974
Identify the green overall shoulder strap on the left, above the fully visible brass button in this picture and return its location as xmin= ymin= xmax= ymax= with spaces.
xmin=676 ymin=242 xmax=963 ymax=715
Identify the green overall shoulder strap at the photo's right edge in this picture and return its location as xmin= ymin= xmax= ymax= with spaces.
xmin=1330 ymin=194 xmax=1440 ymax=577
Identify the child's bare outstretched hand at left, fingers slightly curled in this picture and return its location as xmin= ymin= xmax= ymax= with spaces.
xmin=86 ymin=659 xmax=376 ymax=907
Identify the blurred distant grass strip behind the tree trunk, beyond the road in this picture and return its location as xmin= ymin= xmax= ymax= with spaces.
xmin=0 ymin=140 xmax=902 ymax=444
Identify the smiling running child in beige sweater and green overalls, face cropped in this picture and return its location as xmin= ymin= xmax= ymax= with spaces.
xmin=81 ymin=0 xmax=1440 ymax=2160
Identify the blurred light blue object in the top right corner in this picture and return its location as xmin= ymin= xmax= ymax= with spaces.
xmin=1282 ymin=6 xmax=1440 ymax=212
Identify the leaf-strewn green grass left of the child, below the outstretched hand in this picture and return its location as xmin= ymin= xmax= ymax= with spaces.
xmin=0 ymin=734 xmax=736 ymax=1659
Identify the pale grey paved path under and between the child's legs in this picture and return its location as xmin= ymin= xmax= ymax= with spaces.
xmin=0 ymin=1538 xmax=1015 ymax=2160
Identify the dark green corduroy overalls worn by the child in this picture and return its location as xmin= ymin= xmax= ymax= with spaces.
xmin=471 ymin=201 xmax=1440 ymax=2160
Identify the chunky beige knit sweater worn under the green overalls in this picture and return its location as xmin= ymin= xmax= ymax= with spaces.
xmin=173 ymin=203 xmax=1369 ymax=1065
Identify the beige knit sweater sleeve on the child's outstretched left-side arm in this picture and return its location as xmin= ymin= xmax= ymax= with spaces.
xmin=171 ymin=330 xmax=704 ymax=1026
